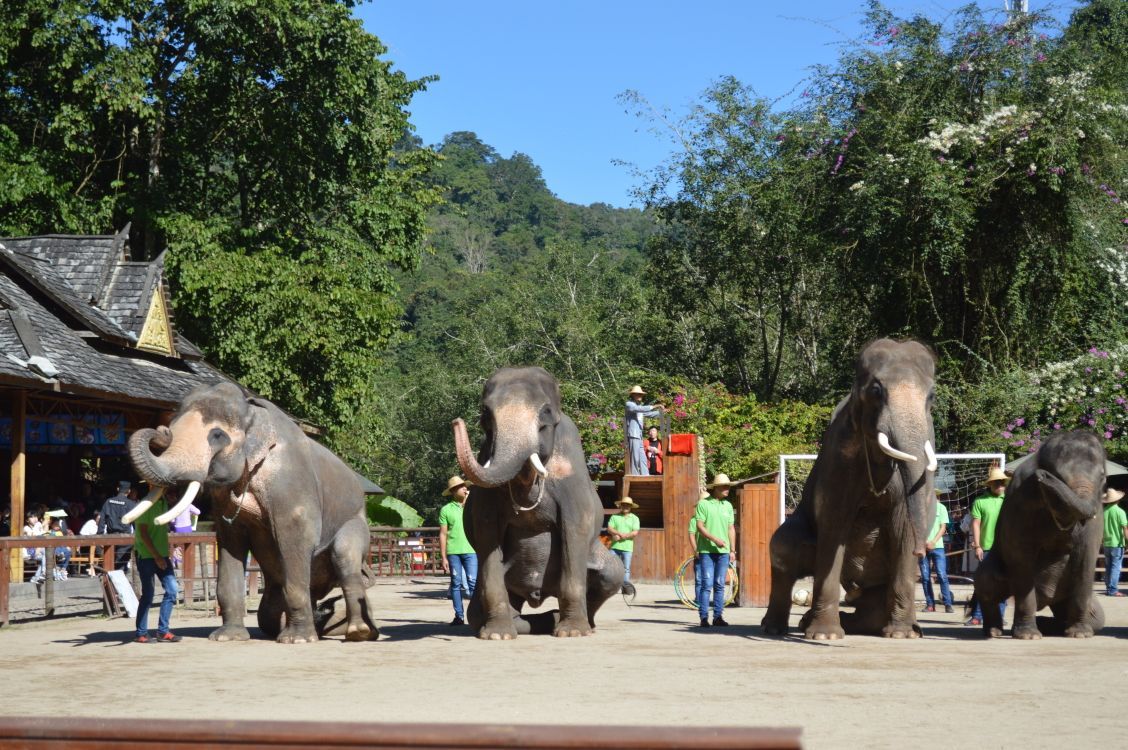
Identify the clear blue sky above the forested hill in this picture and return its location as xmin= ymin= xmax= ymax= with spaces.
xmin=356 ymin=0 xmax=1078 ymax=206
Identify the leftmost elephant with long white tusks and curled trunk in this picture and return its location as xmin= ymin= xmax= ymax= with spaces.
xmin=129 ymin=382 xmax=379 ymax=643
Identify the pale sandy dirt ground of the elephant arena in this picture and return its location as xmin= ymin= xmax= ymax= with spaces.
xmin=0 ymin=579 xmax=1128 ymax=748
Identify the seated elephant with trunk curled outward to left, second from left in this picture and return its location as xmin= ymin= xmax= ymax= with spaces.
xmin=452 ymin=368 xmax=624 ymax=641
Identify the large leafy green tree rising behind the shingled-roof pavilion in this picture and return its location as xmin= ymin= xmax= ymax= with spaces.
xmin=0 ymin=0 xmax=438 ymax=423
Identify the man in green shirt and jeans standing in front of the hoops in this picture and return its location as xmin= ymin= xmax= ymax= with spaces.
xmin=694 ymin=474 xmax=737 ymax=627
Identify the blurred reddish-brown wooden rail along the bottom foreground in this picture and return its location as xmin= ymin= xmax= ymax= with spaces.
xmin=0 ymin=716 xmax=802 ymax=750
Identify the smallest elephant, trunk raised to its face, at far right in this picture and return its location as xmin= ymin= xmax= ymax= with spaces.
xmin=976 ymin=430 xmax=1105 ymax=641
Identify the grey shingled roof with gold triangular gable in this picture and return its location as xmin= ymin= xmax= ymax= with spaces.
xmin=0 ymin=228 xmax=227 ymax=407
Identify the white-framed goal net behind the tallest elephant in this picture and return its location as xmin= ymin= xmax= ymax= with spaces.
xmin=779 ymin=453 xmax=1006 ymax=525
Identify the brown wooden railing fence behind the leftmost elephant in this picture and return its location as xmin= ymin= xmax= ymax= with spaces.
xmin=0 ymin=527 xmax=442 ymax=626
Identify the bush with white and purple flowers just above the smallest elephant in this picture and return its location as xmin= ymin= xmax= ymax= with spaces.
xmin=999 ymin=344 xmax=1128 ymax=456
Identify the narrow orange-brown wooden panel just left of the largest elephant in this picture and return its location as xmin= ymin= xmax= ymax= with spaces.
xmin=737 ymin=484 xmax=779 ymax=607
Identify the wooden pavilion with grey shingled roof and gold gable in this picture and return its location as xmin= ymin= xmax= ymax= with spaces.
xmin=0 ymin=226 xmax=226 ymax=581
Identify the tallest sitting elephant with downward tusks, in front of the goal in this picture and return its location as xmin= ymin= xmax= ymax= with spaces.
xmin=760 ymin=338 xmax=937 ymax=641
